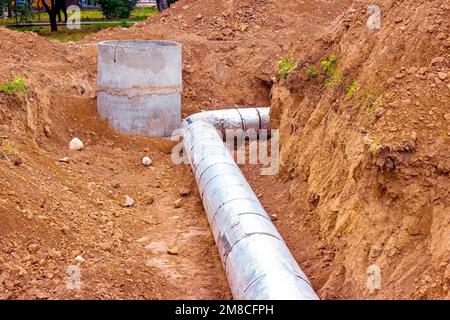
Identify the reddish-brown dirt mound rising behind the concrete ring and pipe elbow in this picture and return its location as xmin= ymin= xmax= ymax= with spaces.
xmin=86 ymin=0 xmax=350 ymax=115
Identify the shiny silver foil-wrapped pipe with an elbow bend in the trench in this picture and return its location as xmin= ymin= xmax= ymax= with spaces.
xmin=183 ymin=108 xmax=318 ymax=300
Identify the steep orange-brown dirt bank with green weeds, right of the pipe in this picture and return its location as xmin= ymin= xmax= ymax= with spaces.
xmin=272 ymin=0 xmax=450 ymax=298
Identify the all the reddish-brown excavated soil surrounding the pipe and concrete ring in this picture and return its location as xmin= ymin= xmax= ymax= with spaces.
xmin=0 ymin=0 xmax=450 ymax=299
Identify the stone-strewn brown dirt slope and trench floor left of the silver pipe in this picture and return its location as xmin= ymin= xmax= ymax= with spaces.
xmin=0 ymin=29 xmax=229 ymax=299
